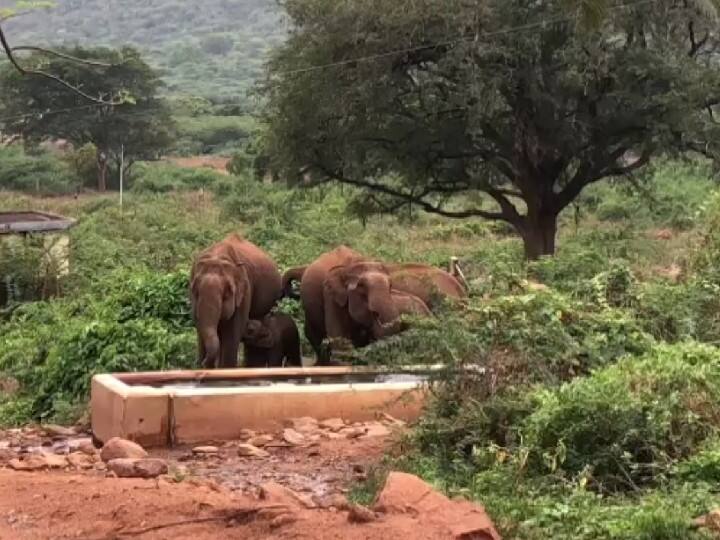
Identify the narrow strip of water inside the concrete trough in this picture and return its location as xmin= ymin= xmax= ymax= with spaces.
xmin=128 ymin=373 xmax=430 ymax=389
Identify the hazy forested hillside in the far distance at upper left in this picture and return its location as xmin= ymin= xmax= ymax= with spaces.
xmin=0 ymin=0 xmax=285 ymax=101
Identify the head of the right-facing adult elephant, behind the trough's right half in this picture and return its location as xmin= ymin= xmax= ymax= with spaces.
xmin=325 ymin=261 xmax=401 ymax=339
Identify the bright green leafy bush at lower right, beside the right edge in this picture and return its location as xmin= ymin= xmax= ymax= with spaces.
xmin=520 ymin=344 xmax=720 ymax=491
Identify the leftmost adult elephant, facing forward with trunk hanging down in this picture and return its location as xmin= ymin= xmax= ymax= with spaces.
xmin=190 ymin=234 xmax=281 ymax=369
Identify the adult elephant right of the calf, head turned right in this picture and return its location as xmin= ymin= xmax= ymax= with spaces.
xmin=283 ymin=246 xmax=400 ymax=365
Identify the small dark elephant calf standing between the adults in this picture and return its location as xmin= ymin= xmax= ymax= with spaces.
xmin=243 ymin=313 xmax=302 ymax=368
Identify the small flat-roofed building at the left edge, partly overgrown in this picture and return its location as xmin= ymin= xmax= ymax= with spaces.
xmin=0 ymin=211 xmax=75 ymax=306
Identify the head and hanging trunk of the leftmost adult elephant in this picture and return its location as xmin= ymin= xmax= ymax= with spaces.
xmin=190 ymin=258 xmax=251 ymax=368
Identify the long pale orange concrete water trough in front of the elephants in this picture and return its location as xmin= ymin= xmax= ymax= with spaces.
xmin=91 ymin=366 xmax=442 ymax=447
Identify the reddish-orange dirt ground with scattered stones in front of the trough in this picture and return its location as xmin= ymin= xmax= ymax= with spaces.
xmin=0 ymin=425 xmax=490 ymax=540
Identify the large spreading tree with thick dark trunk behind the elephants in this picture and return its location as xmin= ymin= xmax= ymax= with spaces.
xmin=264 ymin=0 xmax=720 ymax=258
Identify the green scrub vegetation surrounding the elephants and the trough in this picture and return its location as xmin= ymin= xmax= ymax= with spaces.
xmin=0 ymin=143 xmax=720 ymax=540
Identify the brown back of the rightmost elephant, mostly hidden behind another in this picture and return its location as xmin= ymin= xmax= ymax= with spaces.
xmin=388 ymin=263 xmax=468 ymax=310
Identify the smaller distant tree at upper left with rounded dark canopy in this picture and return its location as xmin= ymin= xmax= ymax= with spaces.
xmin=0 ymin=48 xmax=173 ymax=191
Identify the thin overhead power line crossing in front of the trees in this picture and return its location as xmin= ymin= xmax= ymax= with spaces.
xmin=0 ymin=0 xmax=657 ymax=122
